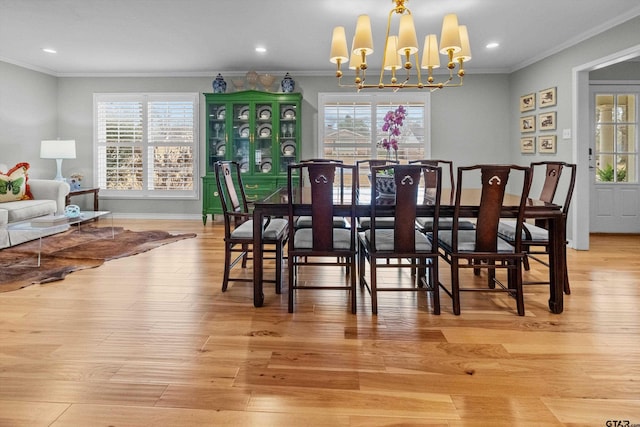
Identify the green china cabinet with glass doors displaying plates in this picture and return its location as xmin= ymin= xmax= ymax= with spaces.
xmin=202 ymin=90 xmax=302 ymax=224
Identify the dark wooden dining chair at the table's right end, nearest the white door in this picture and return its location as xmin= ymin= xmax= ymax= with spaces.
xmin=498 ymin=161 xmax=576 ymax=295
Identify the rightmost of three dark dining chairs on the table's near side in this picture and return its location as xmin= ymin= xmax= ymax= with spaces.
xmin=438 ymin=165 xmax=531 ymax=316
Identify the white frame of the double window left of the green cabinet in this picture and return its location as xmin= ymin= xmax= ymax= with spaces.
xmin=92 ymin=92 xmax=200 ymax=200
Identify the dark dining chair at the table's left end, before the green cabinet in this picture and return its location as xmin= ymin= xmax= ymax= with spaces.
xmin=214 ymin=161 xmax=289 ymax=294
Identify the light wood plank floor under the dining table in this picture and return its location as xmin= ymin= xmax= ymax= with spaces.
xmin=0 ymin=220 xmax=640 ymax=427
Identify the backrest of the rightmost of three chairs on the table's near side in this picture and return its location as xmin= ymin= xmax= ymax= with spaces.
xmin=452 ymin=165 xmax=531 ymax=252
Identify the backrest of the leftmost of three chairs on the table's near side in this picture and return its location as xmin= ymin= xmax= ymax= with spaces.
xmin=287 ymin=162 xmax=357 ymax=252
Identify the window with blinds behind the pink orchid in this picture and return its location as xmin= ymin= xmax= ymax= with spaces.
xmin=318 ymin=92 xmax=431 ymax=164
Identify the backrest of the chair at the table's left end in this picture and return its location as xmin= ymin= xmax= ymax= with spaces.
xmin=214 ymin=161 xmax=249 ymax=232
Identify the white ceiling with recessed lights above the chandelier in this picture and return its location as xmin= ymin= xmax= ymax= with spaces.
xmin=0 ymin=0 xmax=640 ymax=76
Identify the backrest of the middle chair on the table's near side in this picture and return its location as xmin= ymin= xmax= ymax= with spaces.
xmin=370 ymin=164 xmax=442 ymax=253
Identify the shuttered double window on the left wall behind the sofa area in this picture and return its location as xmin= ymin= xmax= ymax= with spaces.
xmin=94 ymin=94 xmax=199 ymax=199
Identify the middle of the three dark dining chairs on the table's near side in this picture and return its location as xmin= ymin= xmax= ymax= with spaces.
xmin=358 ymin=164 xmax=442 ymax=314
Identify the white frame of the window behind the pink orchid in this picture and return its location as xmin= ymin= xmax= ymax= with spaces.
xmin=317 ymin=91 xmax=431 ymax=159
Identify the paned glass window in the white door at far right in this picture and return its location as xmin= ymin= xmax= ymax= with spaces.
xmin=594 ymin=93 xmax=638 ymax=183
